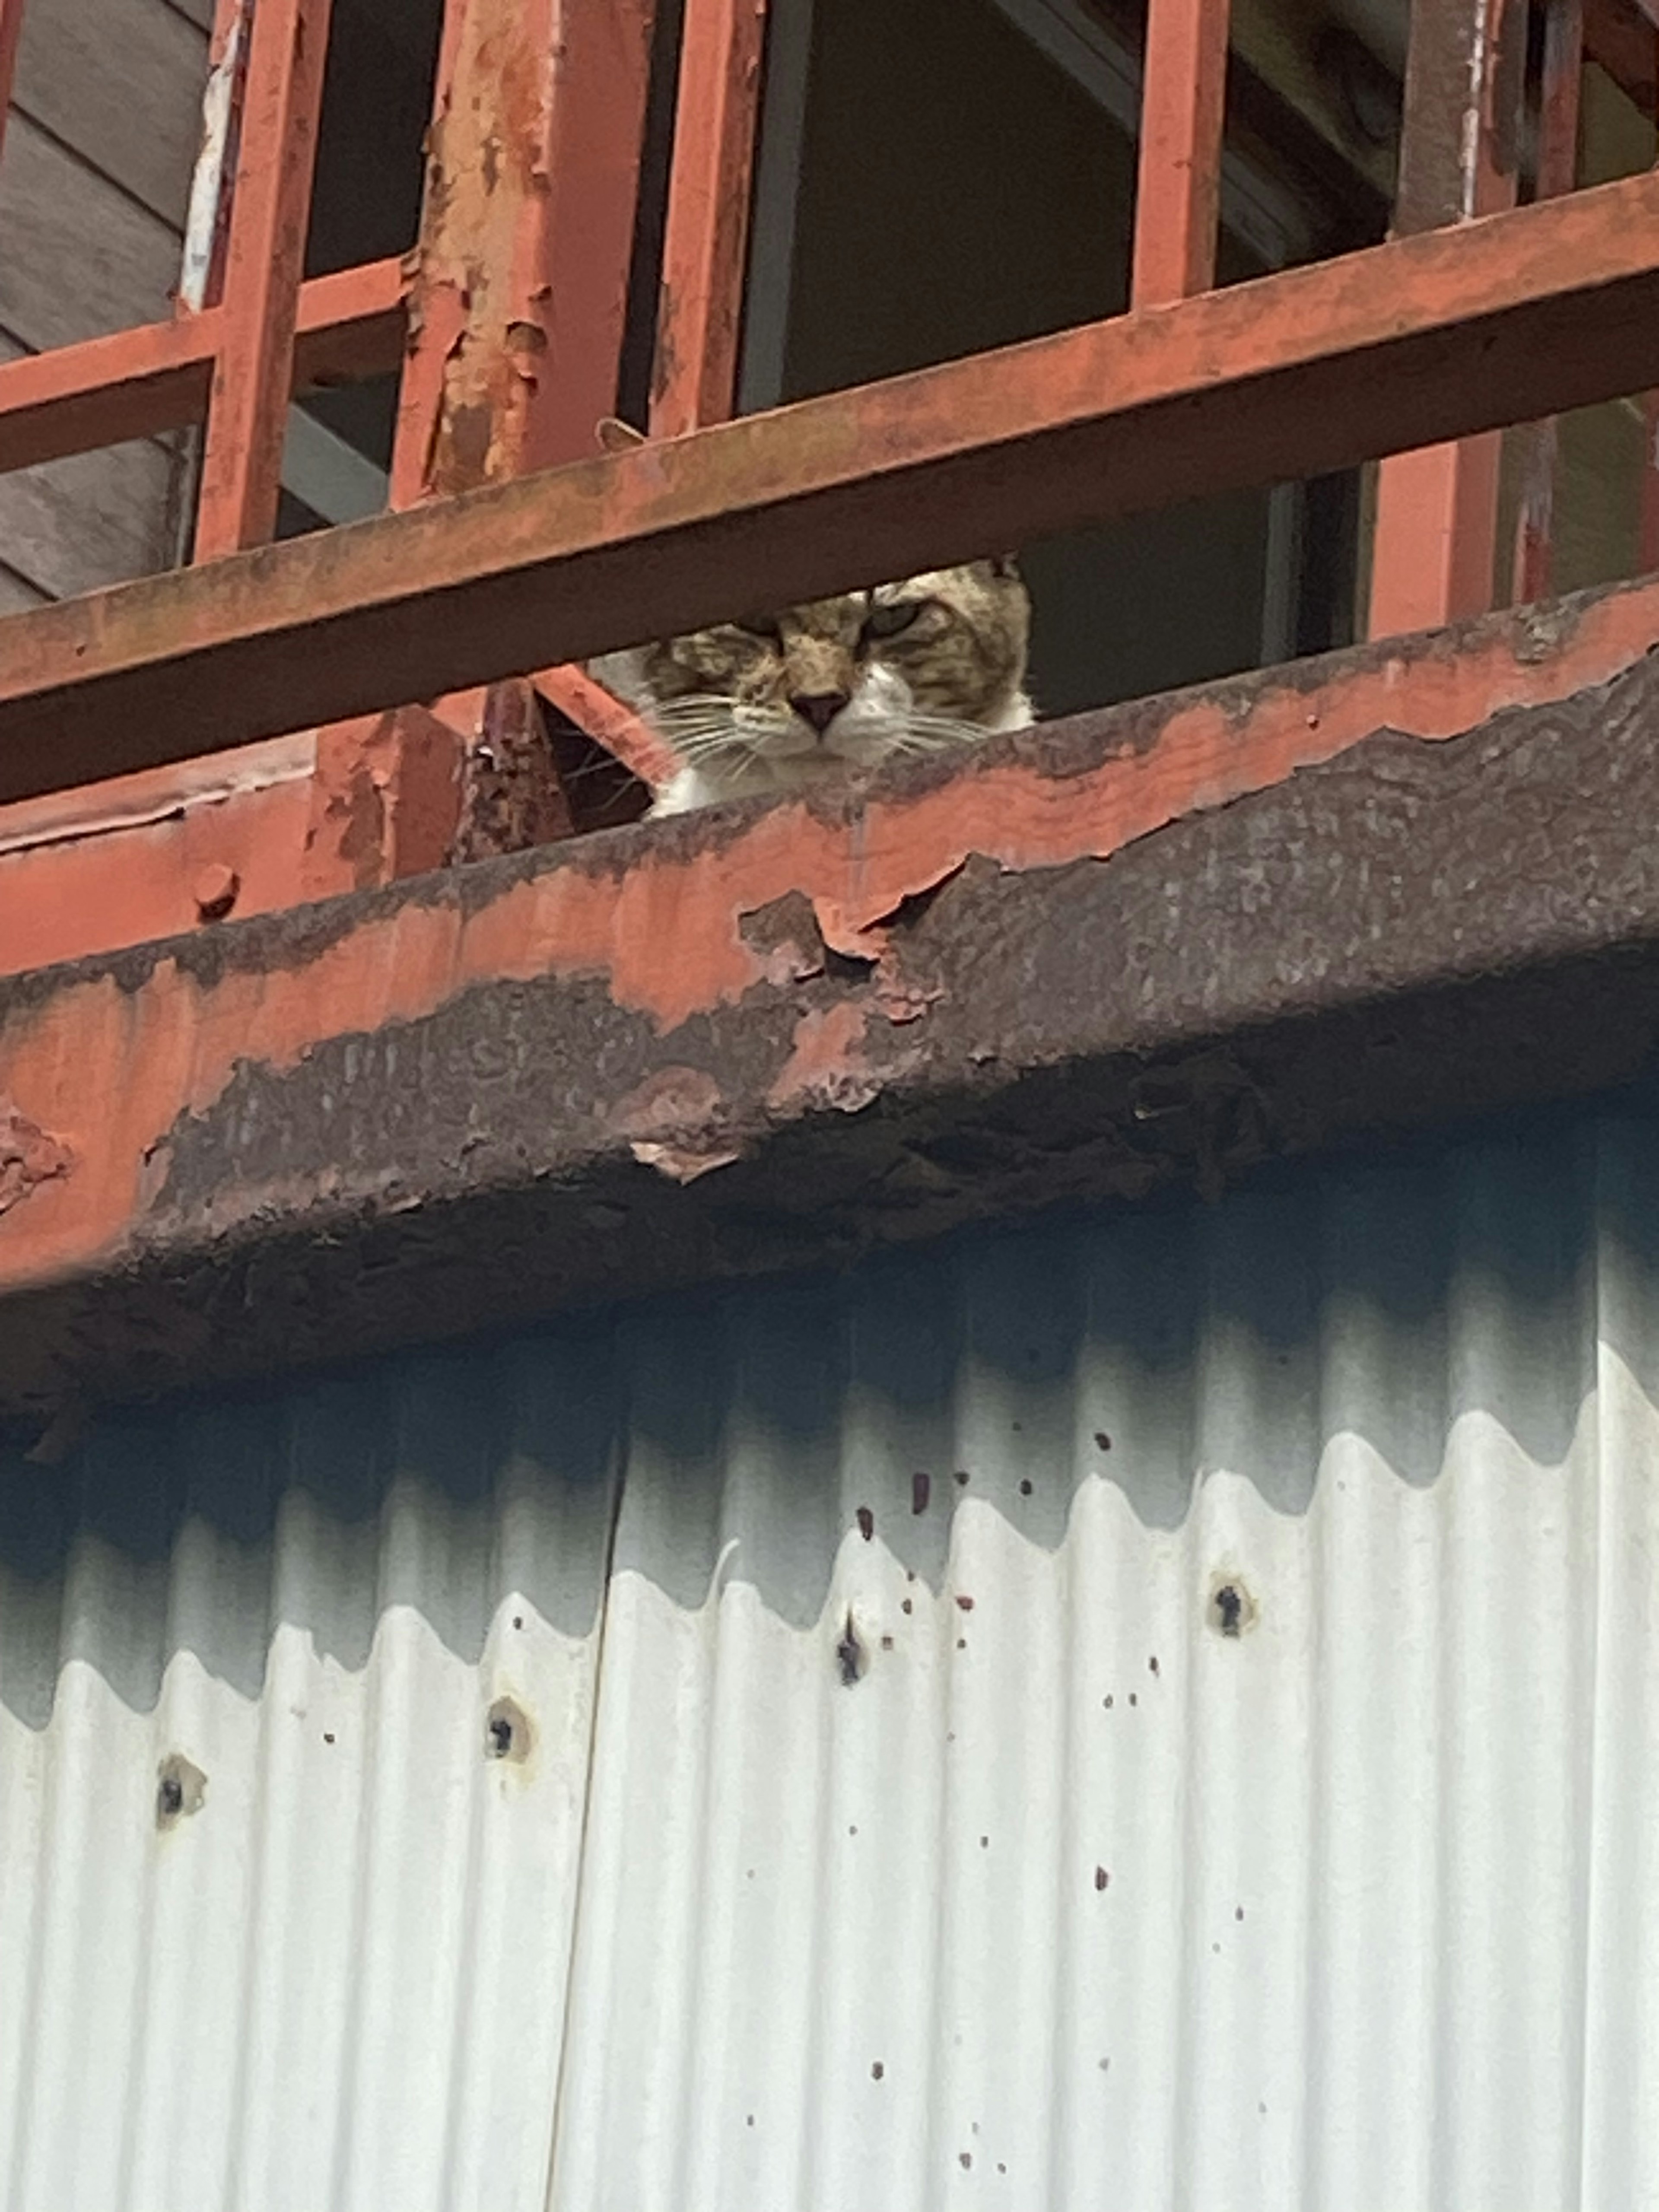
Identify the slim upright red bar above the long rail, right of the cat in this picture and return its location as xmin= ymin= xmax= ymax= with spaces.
xmin=1130 ymin=0 xmax=1228 ymax=308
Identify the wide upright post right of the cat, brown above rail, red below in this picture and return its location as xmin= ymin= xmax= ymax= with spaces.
xmin=1369 ymin=0 xmax=1526 ymax=637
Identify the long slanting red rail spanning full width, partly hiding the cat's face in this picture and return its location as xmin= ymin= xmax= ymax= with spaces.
xmin=0 ymin=175 xmax=1659 ymax=801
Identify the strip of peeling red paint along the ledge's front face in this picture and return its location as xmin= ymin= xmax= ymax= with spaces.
xmin=0 ymin=584 xmax=1659 ymax=1281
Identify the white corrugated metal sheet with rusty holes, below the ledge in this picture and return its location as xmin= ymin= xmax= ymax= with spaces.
xmin=0 ymin=1117 xmax=1659 ymax=2212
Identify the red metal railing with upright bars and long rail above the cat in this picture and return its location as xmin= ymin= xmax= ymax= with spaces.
xmin=0 ymin=0 xmax=1659 ymax=798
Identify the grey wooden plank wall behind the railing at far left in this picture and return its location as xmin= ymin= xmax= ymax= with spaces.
xmin=0 ymin=0 xmax=213 ymax=613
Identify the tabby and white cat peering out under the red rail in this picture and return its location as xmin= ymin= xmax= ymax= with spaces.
xmin=588 ymin=420 xmax=1031 ymax=816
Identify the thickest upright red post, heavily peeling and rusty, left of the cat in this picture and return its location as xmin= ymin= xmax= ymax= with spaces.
xmin=391 ymin=0 xmax=655 ymax=856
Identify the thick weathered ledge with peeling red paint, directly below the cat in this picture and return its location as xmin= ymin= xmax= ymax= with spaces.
xmin=0 ymin=586 xmax=1659 ymax=1431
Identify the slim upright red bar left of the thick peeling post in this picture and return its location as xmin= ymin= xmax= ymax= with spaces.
xmin=195 ymin=0 xmax=330 ymax=559
